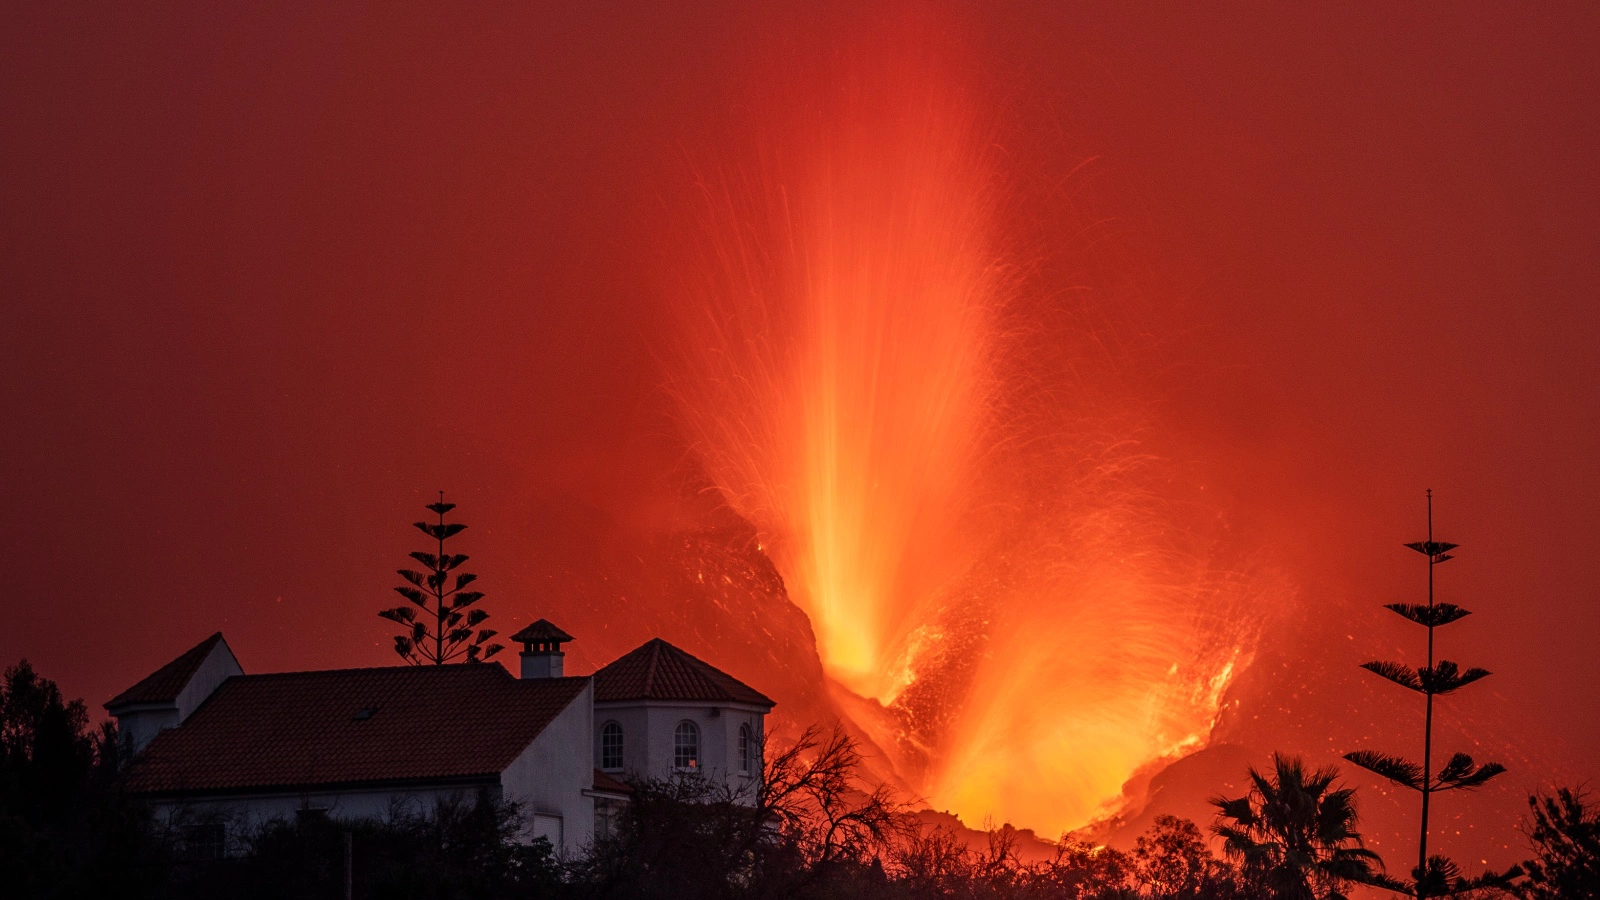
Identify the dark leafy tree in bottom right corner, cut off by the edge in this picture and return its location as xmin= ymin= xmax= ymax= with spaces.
xmin=1517 ymin=788 xmax=1600 ymax=900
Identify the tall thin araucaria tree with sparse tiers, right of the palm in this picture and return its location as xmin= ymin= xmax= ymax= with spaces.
xmin=1344 ymin=490 xmax=1512 ymax=897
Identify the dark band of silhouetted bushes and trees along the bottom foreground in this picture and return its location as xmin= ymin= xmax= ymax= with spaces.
xmin=0 ymin=661 xmax=1600 ymax=900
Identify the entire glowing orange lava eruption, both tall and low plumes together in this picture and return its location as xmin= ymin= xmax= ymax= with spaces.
xmin=666 ymin=35 xmax=1258 ymax=830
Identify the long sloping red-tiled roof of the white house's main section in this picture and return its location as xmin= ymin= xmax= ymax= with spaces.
xmin=128 ymin=665 xmax=589 ymax=793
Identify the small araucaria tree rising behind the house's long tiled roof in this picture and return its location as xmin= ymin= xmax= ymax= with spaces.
xmin=378 ymin=492 xmax=504 ymax=666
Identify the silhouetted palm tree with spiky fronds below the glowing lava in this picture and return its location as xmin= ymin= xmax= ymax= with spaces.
xmin=1211 ymin=756 xmax=1382 ymax=900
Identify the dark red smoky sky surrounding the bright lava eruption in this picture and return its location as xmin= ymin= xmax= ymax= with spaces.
xmin=0 ymin=3 xmax=1600 ymax=871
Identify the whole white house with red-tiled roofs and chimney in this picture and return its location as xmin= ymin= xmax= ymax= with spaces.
xmin=106 ymin=620 xmax=773 ymax=855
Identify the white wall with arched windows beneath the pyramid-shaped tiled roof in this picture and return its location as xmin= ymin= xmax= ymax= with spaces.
xmin=590 ymin=701 xmax=766 ymax=790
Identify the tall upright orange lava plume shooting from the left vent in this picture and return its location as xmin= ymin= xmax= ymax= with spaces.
xmin=678 ymin=68 xmax=1000 ymax=701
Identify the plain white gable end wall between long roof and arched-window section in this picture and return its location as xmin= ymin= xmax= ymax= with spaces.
xmin=501 ymin=682 xmax=595 ymax=857
